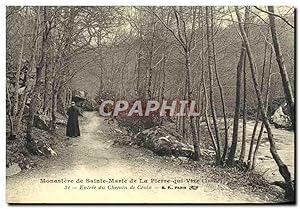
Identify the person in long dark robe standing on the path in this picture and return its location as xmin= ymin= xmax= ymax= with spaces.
xmin=67 ymin=102 xmax=82 ymax=137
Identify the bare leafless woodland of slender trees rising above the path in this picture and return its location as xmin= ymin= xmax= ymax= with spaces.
xmin=6 ymin=6 xmax=295 ymax=199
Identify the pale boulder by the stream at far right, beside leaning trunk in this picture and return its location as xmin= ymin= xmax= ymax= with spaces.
xmin=271 ymin=103 xmax=292 ymax=129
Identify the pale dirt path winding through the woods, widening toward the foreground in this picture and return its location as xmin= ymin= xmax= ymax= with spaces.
xmin=7 ymin=112 xmax=278 ymax=203
